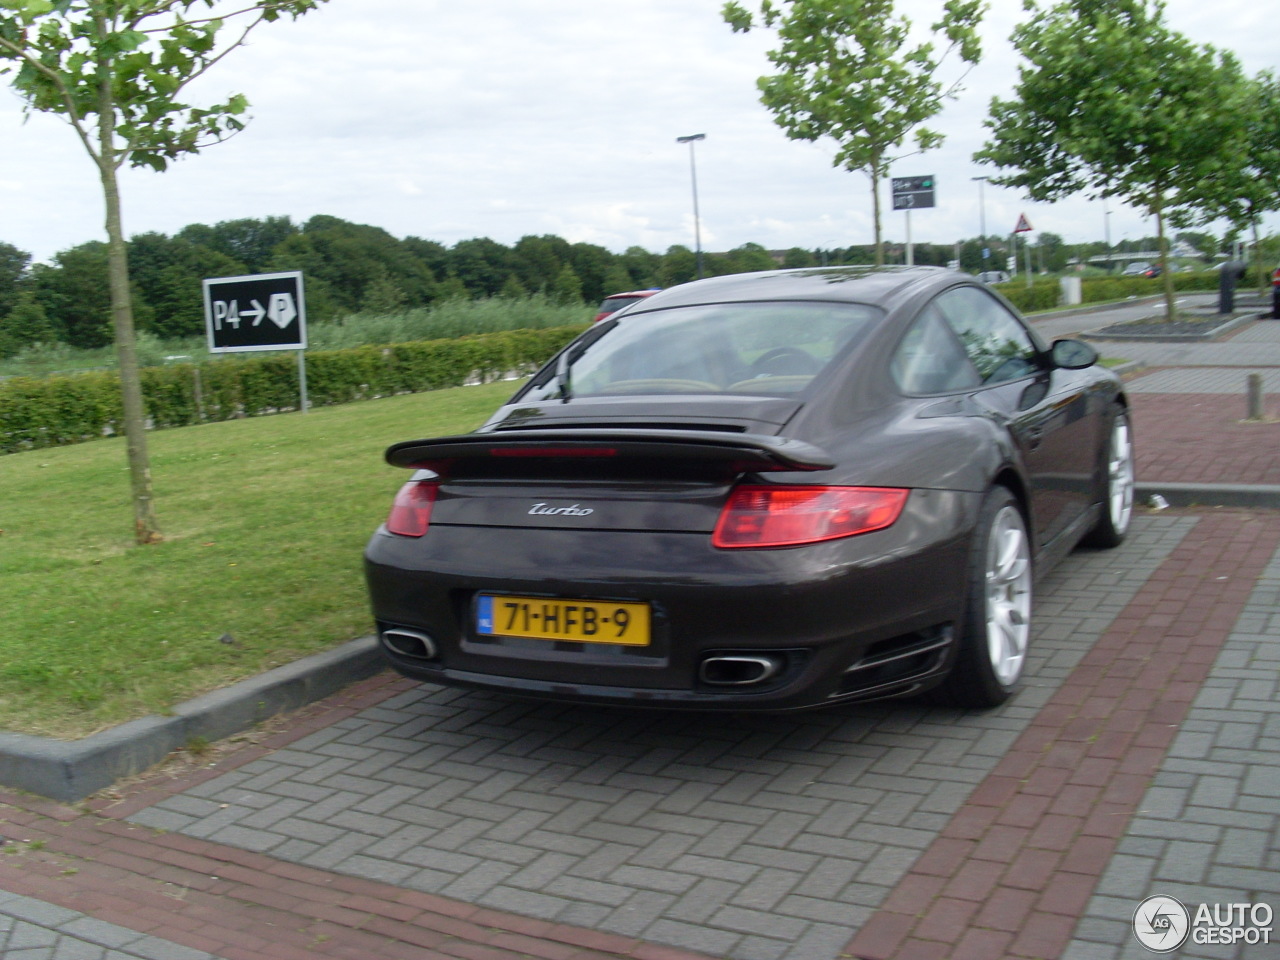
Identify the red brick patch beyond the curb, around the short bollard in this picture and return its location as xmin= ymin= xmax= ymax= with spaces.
xmin=1129 ymin=391 xmax=1280 ymax=484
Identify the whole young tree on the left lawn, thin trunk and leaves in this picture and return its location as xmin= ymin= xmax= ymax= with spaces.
xmin=0 ymin=0 xmax=324 ymax=544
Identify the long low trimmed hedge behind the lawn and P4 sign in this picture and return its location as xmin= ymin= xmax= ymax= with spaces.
xmin=0 ymin=326 xmax=585 ymax=453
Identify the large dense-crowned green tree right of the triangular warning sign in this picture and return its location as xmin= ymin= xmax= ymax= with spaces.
xmin=974 ymin=0 xmax=1245 ymax=319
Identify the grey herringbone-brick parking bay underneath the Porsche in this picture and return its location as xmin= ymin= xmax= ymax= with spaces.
xmin=110 ymin=517 xmax=1188 ymax=960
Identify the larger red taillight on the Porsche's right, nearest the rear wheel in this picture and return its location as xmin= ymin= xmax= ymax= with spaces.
xmin=712 ymin=484 xmax=910 ymax=548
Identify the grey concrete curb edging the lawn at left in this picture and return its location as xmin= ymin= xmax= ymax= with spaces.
xmin=0 ymin=636 xmax=384 ymax=803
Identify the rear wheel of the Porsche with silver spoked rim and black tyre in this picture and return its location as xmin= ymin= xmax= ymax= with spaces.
xmin=934 ymin=486 xmax=1032 ymax=708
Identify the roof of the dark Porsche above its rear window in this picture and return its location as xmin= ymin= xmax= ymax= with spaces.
xmin=627 ymin=266 xmax=973 ymax=316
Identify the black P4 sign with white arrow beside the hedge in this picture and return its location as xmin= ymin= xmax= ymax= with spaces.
xmin=205 ymin=270 xmax=307 ymax=353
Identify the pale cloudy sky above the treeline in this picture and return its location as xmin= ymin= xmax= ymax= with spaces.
xmin=0 ymin=0 xmax=1280 ymax=267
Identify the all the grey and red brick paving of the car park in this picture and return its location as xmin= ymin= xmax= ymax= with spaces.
xmin=0 ymin=302 xmax=1280 ymax=960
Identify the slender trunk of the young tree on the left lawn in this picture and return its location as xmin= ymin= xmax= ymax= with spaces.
xmin=97 ymin=56 xmax=164 ymax=544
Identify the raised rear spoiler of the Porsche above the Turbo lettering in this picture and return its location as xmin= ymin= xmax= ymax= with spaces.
xmin=387 ymin=428 xmax=835 ymax=476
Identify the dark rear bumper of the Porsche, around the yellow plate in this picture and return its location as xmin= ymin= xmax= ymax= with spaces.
xmin=365 ymin=492 xmax=978 ymax=710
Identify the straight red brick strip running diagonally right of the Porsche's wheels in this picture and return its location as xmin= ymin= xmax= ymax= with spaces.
xmin=845 ymin=512 xmax=1280 ymax=960
